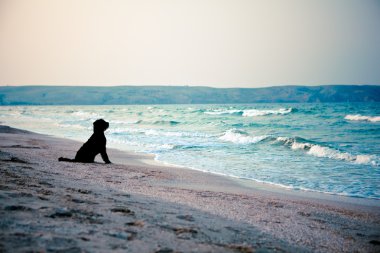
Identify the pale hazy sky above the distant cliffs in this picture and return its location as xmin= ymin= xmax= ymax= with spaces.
xmin=0 ymin=0 xmax=380 ymax=87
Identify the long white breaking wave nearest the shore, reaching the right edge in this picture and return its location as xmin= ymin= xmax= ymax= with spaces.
xmin=276 ymin=137 xmax=379 ymax=166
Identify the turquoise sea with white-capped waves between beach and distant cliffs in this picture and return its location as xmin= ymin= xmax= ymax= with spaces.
xmin=0 ymin=103 xmax=380 ymax=199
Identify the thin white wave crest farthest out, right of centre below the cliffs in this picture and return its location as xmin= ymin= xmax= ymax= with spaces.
xmin=204 ymin=108 xmax=295 ymax=117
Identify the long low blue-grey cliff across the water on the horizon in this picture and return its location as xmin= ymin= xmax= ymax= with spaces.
xmin=0 ymin=85 xmax=380 ymax=105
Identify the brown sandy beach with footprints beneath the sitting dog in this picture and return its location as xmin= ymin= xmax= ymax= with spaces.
xmin=0 ymin=126 xmax=380 ymax=253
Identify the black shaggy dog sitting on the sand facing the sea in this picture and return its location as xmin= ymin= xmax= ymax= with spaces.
xmin=58 ymin=119 xmax=111 ymax=163
